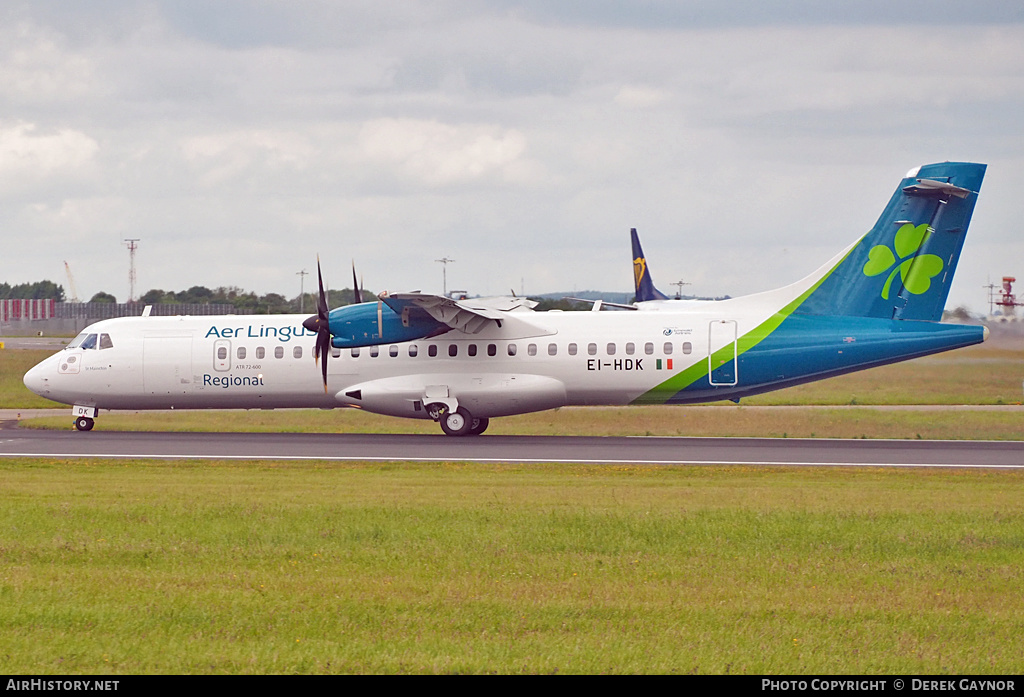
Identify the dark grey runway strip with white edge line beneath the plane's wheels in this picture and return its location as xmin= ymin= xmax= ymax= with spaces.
xmin=0 ymin=429 xmax=1024 ymax=469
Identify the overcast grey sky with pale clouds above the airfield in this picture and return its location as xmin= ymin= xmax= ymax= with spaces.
xmin=0 ymin=0 xmax=1024 ymax=311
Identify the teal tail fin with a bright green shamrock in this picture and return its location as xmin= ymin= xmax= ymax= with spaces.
xmin=797 ymin=162 xmax=986 ymax=321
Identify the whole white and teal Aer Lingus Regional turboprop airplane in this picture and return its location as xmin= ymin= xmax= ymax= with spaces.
xmin=25 ymin=163 xmax=988 ymax=436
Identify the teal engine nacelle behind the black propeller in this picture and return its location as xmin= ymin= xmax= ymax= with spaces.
xmin=328 ymin=302 xmax=451 ymax=348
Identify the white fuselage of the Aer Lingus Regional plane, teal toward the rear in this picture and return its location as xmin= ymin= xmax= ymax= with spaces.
xmin=25 ymin=301 xmax=984 ymax=419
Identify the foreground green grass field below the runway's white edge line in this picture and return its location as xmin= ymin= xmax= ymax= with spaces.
xmin=0 ymin=460 xmax=1024 ymax=674
